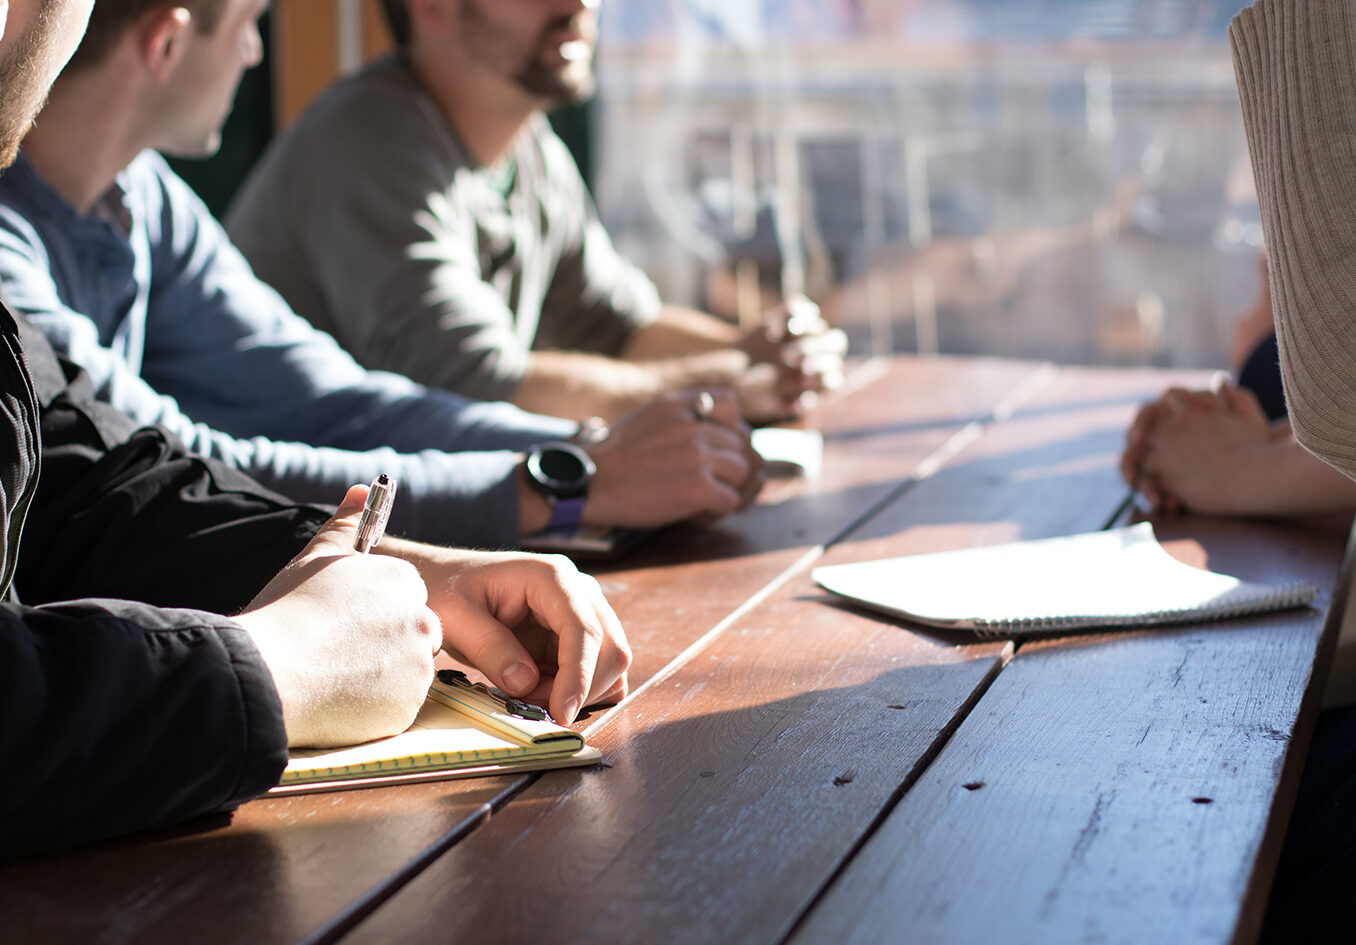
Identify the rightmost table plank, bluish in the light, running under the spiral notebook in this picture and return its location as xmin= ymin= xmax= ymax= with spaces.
xmin=792 ymin=519 xmax=1344 ymax=944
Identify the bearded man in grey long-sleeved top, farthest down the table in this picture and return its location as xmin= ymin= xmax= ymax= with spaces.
xmin=228 ymin=0 xmax=845 ymax=422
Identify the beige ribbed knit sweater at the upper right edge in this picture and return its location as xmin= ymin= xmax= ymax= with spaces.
xmin=1229 ymin=0 xmax=1356 ymax=479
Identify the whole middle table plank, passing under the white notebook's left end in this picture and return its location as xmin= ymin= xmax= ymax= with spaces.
xmin=330 ymin=371 xmax=1209 ymax=944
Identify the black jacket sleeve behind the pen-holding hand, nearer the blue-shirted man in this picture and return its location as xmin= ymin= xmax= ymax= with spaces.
xmin=15 ymin=313 xmax=330 ymax=614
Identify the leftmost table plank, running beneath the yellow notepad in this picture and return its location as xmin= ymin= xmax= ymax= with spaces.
xmin=0 ymin=361 xmax=1035 ymax=944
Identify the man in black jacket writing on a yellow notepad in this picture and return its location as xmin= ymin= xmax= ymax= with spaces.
xmin=0 ymin=0 xmax=631 ymax=858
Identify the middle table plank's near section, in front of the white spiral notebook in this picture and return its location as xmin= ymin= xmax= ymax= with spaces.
xmin=333 ymin=564 xmax=1019 ymax=945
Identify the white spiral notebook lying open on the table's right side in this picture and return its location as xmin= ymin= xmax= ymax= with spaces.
xmin=812 ymin=522 xmax=1319 ymax=636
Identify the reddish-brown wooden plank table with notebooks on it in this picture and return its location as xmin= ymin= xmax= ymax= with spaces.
xmin=0 ymin=358 xmax=1345 ymax=945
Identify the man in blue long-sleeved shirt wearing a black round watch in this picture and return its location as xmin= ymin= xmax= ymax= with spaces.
xmin=0 ymin=0 xmax=762 ymax=548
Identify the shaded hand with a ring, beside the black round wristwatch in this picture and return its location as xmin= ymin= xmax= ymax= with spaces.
xmin=583 ymin=390 xmax=765 ymax=529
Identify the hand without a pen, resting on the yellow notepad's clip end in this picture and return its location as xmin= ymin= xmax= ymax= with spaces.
xmin=398 ymin=541 xmax=631 ymax=724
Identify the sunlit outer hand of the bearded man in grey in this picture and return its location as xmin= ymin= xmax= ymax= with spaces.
xmin=735 ymin=296 xmax=848 ymax=423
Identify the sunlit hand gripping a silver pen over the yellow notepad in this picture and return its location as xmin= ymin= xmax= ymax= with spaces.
xmin=235 ymin=485 xmax=442 ymax=747
